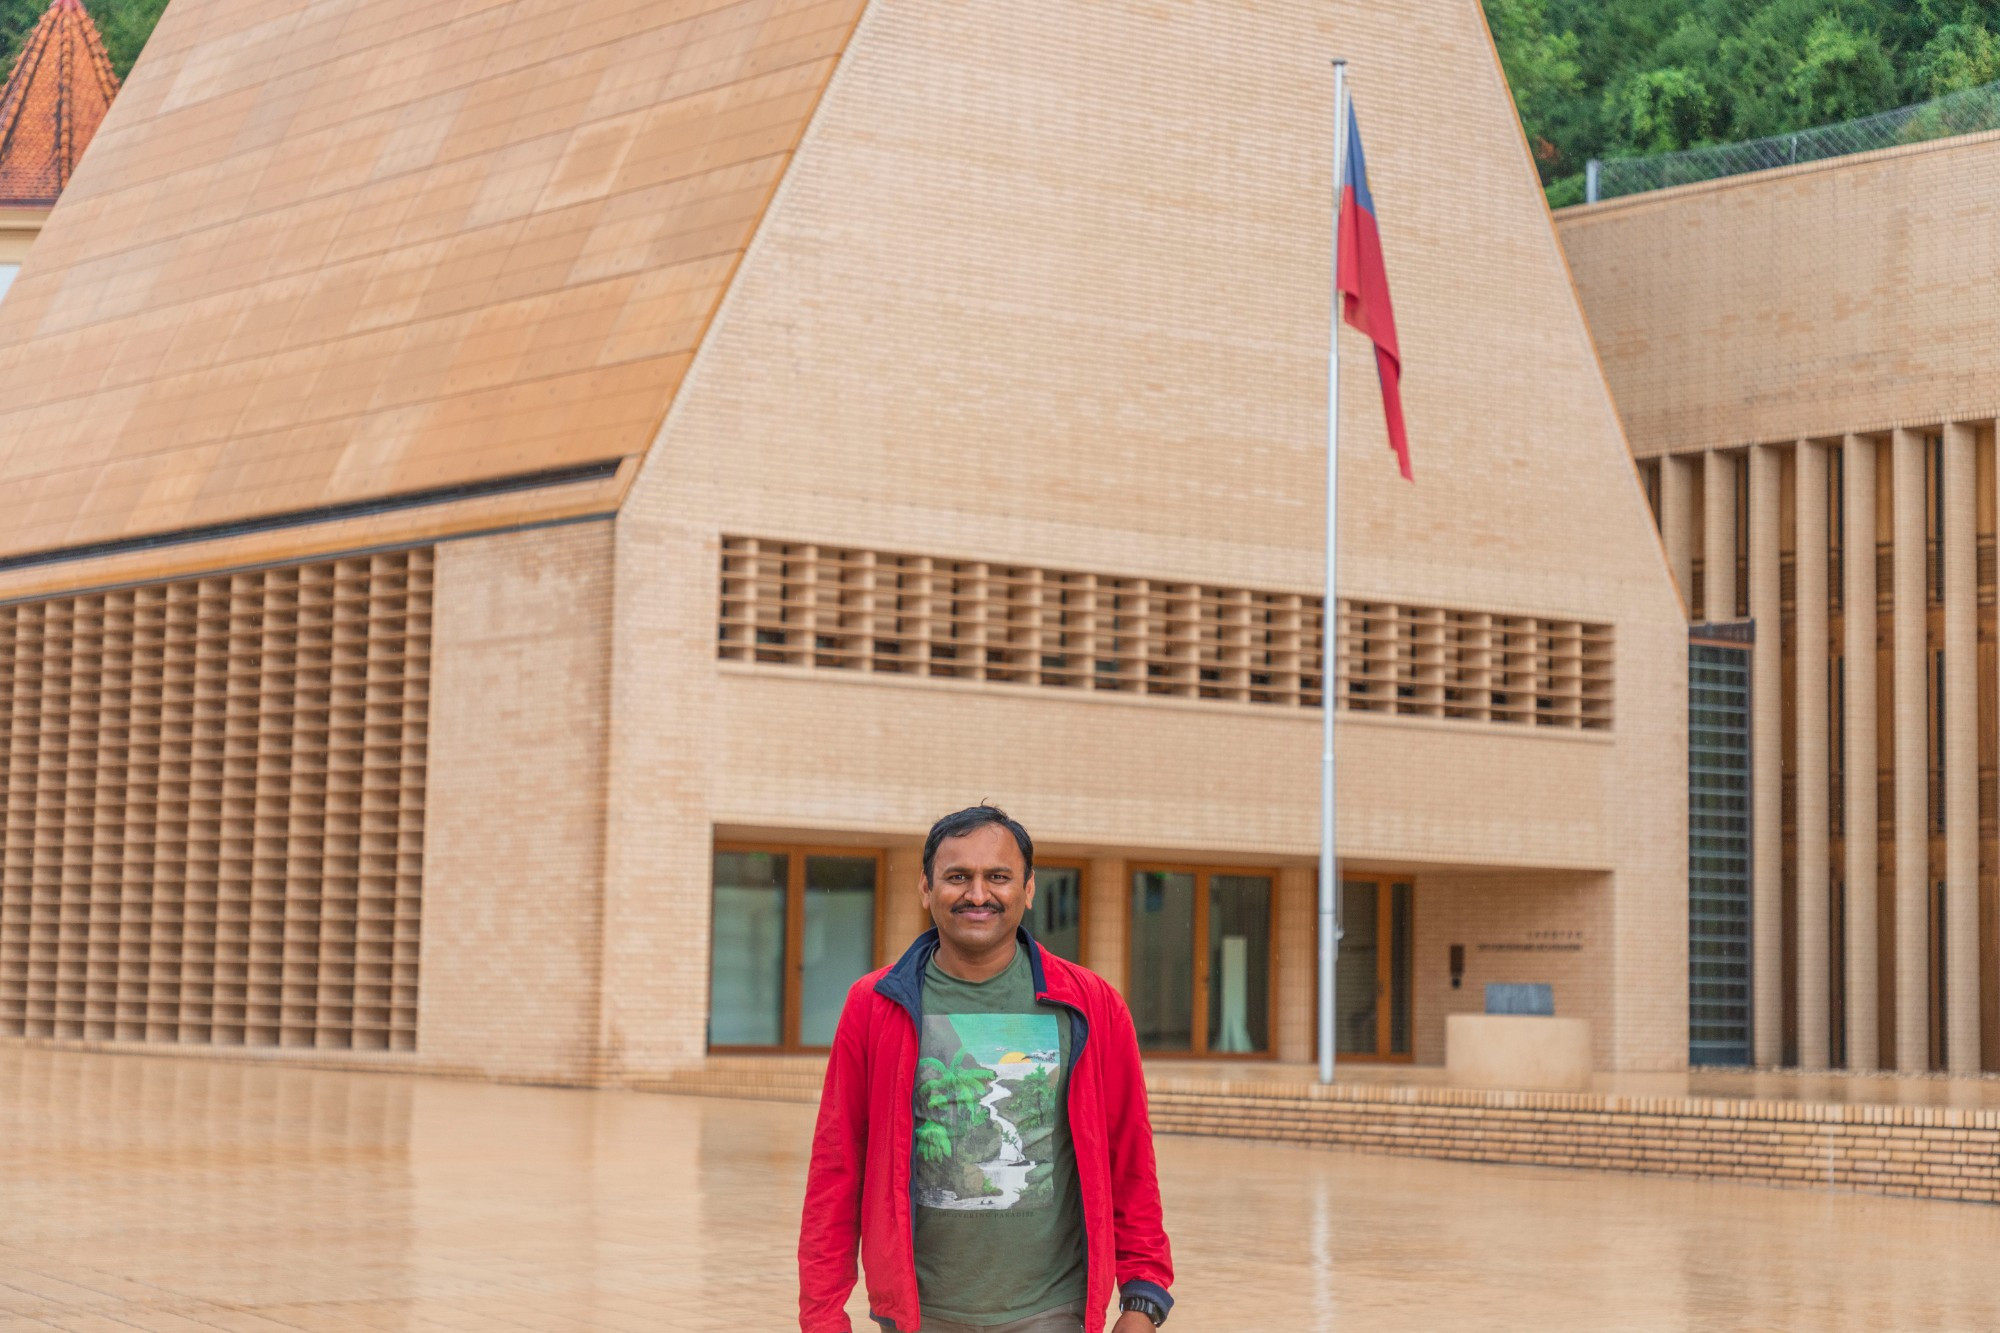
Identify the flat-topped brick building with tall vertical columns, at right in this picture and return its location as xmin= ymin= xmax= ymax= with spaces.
xmin=1558 ymin=134 xmax=2000 ymax=1073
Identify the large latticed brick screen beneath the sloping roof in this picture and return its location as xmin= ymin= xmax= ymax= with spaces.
xmin=0 ymin=550 xmax=432 ymax=1051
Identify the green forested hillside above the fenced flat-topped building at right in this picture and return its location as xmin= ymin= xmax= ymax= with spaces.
xmin=1484 ymin=0 xmax=2000 ymax=204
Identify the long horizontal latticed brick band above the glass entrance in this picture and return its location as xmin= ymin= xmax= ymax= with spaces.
xmin=718 ymin=536 xmax=1612 ymax=731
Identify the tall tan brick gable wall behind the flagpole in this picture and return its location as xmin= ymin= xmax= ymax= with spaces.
xmin=610 ymin=0 xmax=1686 ymax=1067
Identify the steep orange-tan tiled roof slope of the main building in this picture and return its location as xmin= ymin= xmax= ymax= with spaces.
xmin=0 ymin=0 xmax=864 ymax=592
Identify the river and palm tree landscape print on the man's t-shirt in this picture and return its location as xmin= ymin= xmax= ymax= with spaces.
xmin=916 ymin=1013 xmax=1062 ymax=1213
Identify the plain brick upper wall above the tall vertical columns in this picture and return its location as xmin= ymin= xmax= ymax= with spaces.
xmin=1558 ymin=134 xmax=2000 ymax=456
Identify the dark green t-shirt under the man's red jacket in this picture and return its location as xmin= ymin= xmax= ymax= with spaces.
xmin=916 ymin=949 xmax=1086 ymax=1325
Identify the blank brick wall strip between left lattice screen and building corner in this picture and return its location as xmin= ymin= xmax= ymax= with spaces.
xmin=418 ymin=522 xmax=612 ymax=1081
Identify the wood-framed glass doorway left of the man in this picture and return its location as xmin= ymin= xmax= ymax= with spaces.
xmin=708 ymin=845 xmax=882 ymax=1051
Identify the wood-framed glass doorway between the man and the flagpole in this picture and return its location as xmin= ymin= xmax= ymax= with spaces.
xmin=1128 ymin=867 xmax=1276 ymax=1057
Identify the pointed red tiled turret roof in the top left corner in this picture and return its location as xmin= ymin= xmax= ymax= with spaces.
xmin=0 ymin=0 xmax=118 ymax=204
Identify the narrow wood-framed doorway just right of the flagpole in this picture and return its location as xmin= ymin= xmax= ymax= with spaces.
xmin=1334 ymin=879 xmax=1416 ymax=1061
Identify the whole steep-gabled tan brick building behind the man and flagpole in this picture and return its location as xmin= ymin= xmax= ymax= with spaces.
xmin=0 ymin=0 xmax=1688 ymax=1083
